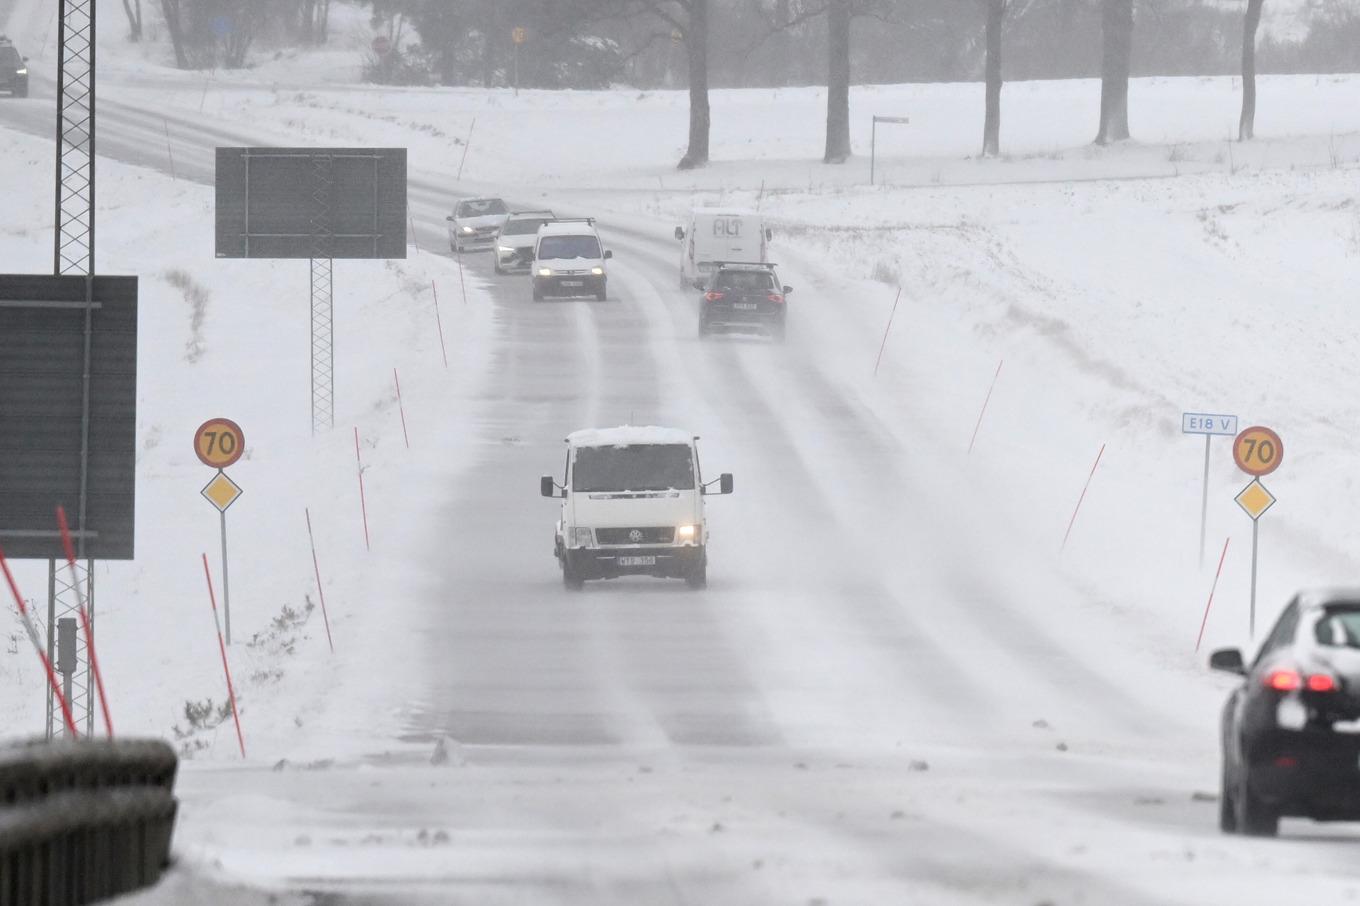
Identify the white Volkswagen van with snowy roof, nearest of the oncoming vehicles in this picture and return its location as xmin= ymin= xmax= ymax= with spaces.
xmin=539 ymin=426 xmax=732 ymax=590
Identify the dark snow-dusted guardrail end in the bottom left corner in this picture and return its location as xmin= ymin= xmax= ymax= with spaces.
xmin=0 ymin=740 xmax=178 ymax=906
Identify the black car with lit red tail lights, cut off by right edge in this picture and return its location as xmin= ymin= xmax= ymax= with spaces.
xmin=1209 ymin=589 xmax=1360 ymax=837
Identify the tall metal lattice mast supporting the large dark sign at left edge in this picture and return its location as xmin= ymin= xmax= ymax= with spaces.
xmin=48 ymin=0 xmax=97 ymax=737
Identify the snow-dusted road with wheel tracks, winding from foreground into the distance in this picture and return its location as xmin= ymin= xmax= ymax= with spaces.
xmin=0 ymin=8 xmax=1360 ymax=906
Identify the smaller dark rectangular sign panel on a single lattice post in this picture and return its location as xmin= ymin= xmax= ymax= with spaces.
xmin=216 ymin=148 xmax=407 ymax=258
